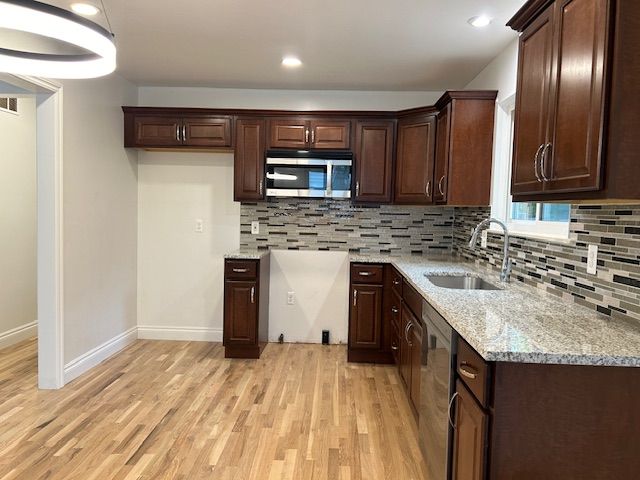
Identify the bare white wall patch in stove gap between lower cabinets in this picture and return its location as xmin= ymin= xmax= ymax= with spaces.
xmin=269 ymin=251 xmax=349 ymax=343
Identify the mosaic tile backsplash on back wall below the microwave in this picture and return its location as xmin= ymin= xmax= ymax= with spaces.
xmin=240 ymin=199 xmax=454 ymax=254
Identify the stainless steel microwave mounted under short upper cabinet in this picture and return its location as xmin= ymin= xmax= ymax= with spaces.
xmin=266 ymin=150 xmax=353 ymax=198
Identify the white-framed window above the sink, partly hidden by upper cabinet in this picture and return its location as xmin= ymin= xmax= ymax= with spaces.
xmin=491 ymin=95 xmax=571 ymax=239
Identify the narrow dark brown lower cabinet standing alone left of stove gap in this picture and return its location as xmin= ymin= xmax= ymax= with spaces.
xmin=223 ymin=255 xmax=269 ymax=358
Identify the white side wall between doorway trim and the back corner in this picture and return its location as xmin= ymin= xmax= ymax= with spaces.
xmin=63 ymin=74 xmax=138 ymax=366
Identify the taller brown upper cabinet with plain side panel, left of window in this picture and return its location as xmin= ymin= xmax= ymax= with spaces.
xmin=433 ymin=91 xmax=497 ymax=206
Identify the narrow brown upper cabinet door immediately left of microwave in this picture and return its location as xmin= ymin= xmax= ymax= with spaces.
xmin=233 ymin=119 xmax=265 ymax=202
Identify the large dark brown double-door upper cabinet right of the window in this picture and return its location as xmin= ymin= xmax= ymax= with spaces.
xmin=508 ymin=0 xmax=640 ymax=201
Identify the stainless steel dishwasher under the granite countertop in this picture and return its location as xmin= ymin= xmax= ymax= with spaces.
xmin=418 ymin=301 xmax=455 ymax=480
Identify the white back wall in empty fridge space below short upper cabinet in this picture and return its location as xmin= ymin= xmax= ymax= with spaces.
xmin=138 ymin=152 xmax=240 ymax=341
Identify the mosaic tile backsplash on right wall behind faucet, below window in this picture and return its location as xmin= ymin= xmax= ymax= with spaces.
xmin=453 ymin=205 xmax=640 ymax=320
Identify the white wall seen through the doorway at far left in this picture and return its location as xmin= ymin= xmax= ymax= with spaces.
xmin=0 ymin=95 xmax=37 ymax=348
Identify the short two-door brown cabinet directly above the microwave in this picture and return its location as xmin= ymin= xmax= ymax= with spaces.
xmin=269 ymin=118 xmax=351 ymax=150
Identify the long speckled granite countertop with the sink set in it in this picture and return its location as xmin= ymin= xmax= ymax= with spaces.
xmin=350 ymin=255 xmax=640 ymax=367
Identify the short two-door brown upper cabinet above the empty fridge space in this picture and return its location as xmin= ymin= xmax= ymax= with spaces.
xmin=124 ymin=110 xmax=231 ymax=148
